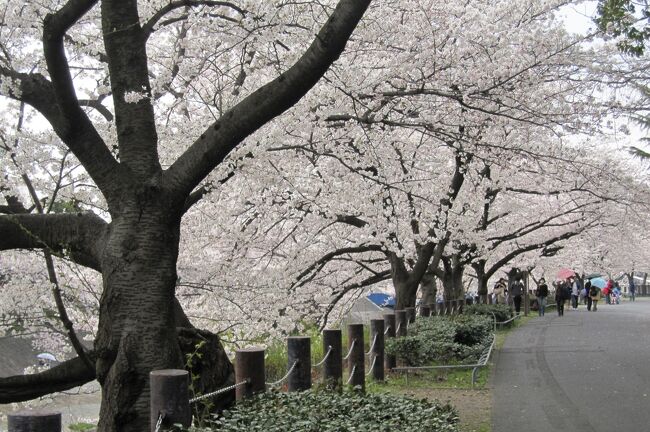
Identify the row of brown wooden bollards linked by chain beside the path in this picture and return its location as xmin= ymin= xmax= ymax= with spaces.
xmin=8 ymin=300 xmax=464 ymax=432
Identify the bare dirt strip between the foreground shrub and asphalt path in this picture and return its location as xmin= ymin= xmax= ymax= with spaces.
xmin=404 ymin=388 xmax=492 ymax=432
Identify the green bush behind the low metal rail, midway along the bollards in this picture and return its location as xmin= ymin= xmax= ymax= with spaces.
xmin=386 ymin=315 xmax=493 ymax=366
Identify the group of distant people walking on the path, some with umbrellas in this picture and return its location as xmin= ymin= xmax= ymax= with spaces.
xmin=492 ymin=276 xmax=635 ymax=316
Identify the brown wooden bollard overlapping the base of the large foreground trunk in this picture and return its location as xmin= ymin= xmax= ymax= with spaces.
xmin=149 ymin=369 xmax=192 ymax=432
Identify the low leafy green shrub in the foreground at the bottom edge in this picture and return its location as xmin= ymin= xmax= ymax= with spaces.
xmin=197 ymin=390 xmax=458 ymax=432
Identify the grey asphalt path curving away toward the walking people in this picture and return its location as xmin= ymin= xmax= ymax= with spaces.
xmin=492 ymin=298 xmax=650 ymax=432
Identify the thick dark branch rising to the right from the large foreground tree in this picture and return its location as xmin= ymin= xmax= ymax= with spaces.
xmin=165 ymin=0 xmax=370 ymax=196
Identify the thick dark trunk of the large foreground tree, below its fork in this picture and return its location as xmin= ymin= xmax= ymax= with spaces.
xmin=95 ymin=196 xmax=232 ymax=432
